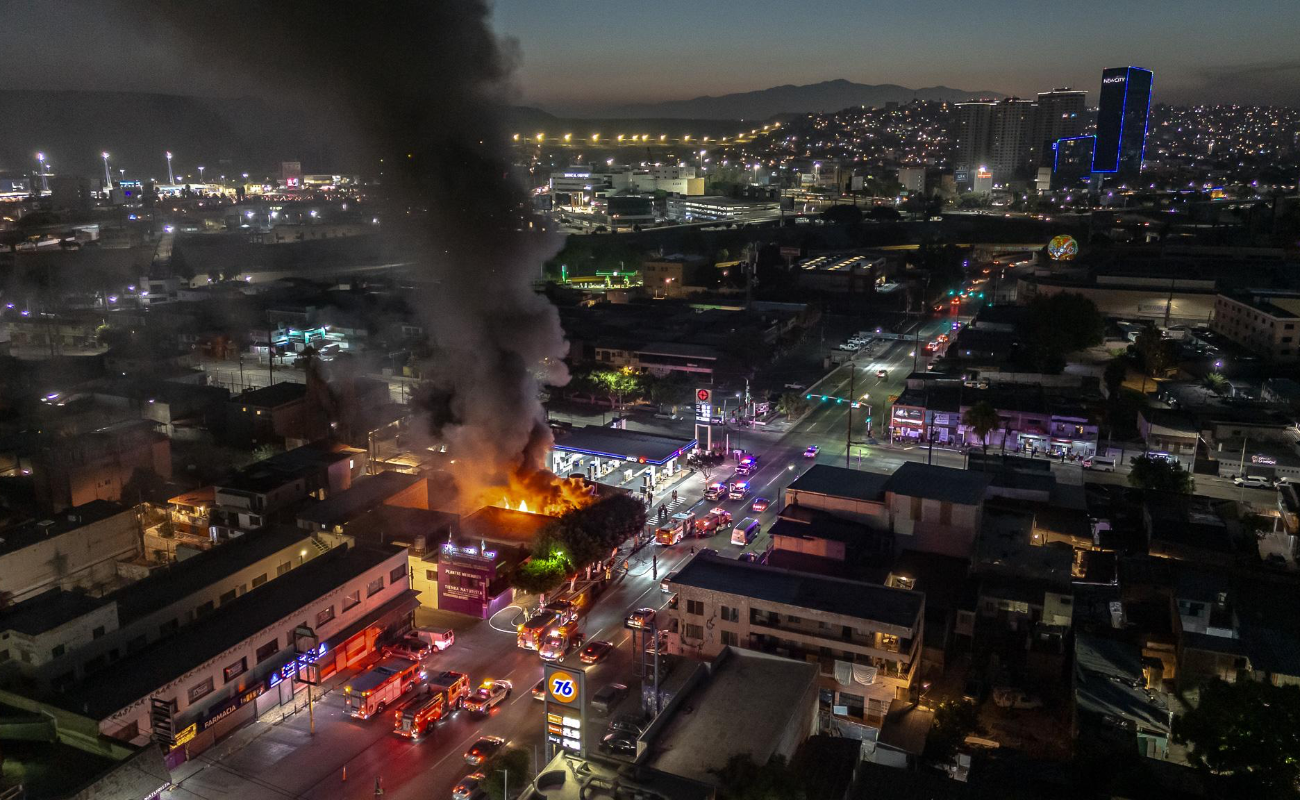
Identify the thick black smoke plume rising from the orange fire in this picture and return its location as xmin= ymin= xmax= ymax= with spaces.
xmin=124 ymin=0 xmax=568 ymax=498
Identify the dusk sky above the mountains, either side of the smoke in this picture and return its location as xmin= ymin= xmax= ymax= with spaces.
xmin=0 ymin=0 xmax=1300 ymax=111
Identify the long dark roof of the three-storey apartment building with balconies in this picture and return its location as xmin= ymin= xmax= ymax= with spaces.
xmin=672 ymin=553 xmax=926 ymax=628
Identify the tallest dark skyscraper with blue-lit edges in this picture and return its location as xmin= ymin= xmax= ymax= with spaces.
xmin=1092 ymin=66 xmax=1152 ymax=180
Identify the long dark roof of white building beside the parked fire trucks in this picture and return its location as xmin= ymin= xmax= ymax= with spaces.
xmin=51 ymin=545 xmax=400 ymax=719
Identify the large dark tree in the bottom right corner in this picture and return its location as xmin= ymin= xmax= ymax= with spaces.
xmin=1173 ymin=678 xmax=1300 ymax=800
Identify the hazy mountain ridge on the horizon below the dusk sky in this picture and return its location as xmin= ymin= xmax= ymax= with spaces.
xmin=543 ymin=78 xmax=1006 ymax=120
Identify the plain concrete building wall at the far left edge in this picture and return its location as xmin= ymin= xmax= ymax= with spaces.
xmin=0 ymin=509 xmax=140 ymax=602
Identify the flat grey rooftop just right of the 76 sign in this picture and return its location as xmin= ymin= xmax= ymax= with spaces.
xmin=646 ymin=648 xmax=818 ymax=783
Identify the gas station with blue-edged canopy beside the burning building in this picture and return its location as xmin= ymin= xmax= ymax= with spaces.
xmin=550 ymin=425 xmax=698 ymax=490
